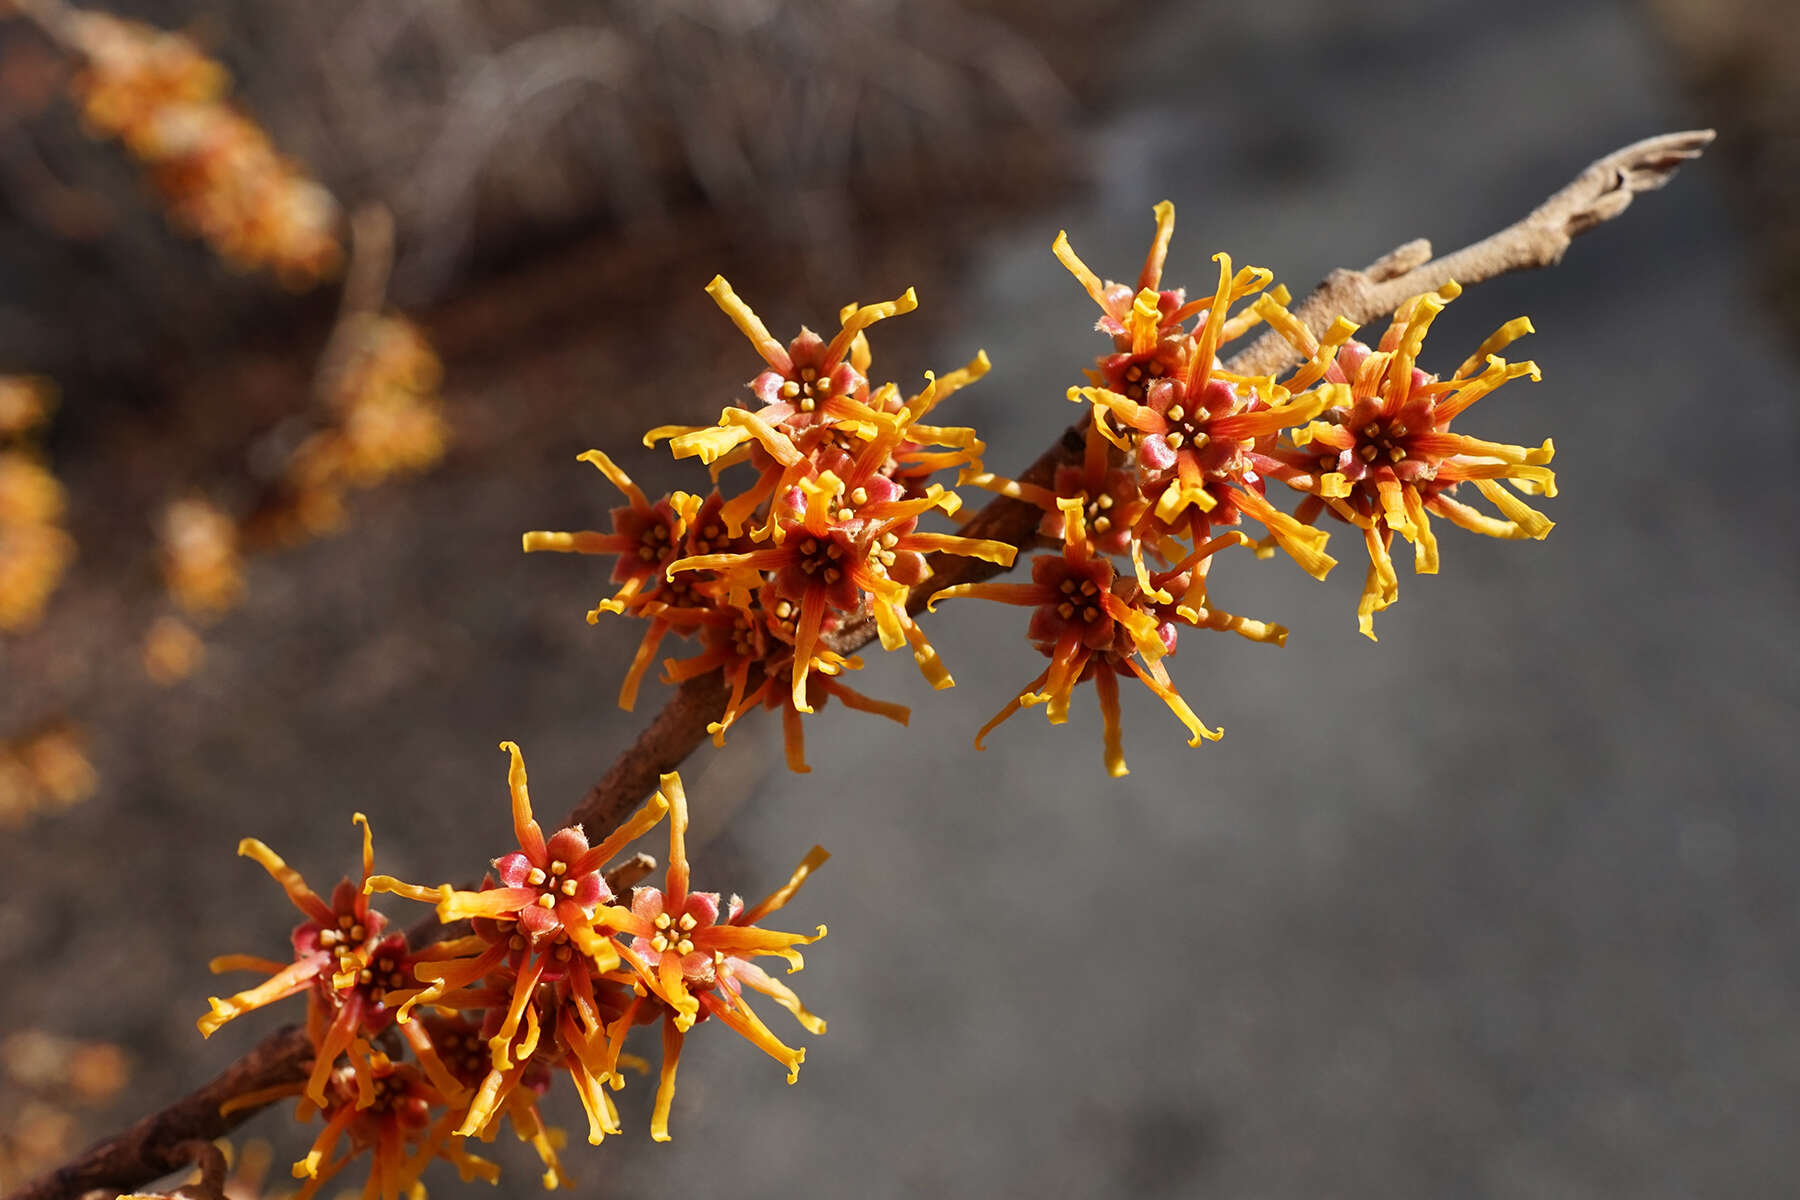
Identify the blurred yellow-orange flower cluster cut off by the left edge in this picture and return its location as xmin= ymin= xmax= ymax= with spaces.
xmin=0 ymin=376 xmax=76 ymax=633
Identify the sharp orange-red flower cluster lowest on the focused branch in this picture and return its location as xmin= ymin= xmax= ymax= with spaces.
xmin=200 ymin=741 xmax=826 ymax=1200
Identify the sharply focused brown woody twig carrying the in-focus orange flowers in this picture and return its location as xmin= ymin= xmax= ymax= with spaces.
xmin=7 ymin=130 xmax=1714 ymax=1200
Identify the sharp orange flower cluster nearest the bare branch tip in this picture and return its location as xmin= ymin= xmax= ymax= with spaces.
xmin=932 ymin=201 xmax=1555 ymax=775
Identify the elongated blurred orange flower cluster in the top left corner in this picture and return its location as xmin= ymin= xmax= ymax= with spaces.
xmin=59 ymin=11 xmax=344 ymax=288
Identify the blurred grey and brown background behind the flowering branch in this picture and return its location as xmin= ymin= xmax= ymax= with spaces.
xmin=0 ymin=0 xmax=1800 ymax=1200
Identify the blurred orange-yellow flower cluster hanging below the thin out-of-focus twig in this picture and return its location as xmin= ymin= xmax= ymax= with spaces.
xmin=277 ymin=313 xmax=450 ymax=542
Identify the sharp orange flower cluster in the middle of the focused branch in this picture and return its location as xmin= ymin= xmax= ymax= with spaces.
xmin=524 ymin=277 xmax=1013 ymax=772
